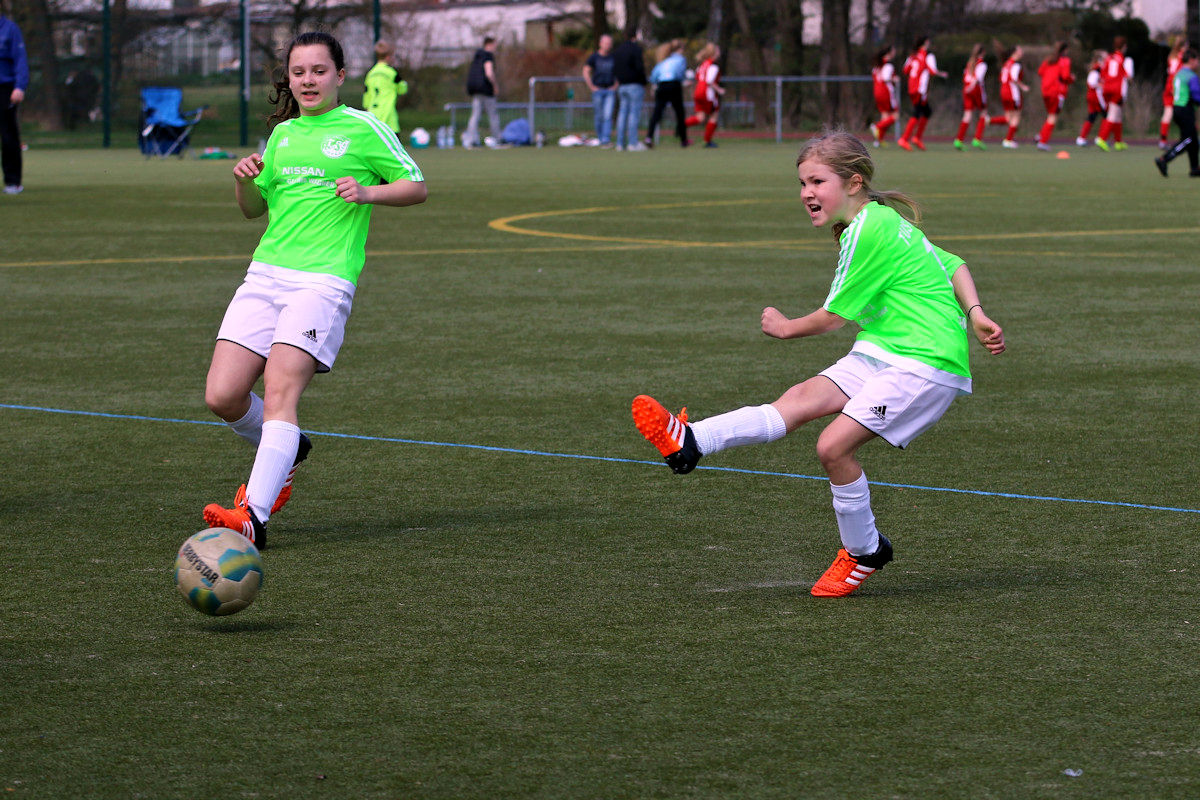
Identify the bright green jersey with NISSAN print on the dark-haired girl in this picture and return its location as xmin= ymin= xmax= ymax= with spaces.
xmin=254 ymin=106 xmax=425 ymax=284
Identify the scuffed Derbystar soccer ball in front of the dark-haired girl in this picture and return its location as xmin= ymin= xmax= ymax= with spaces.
xmin=175 ymin=528 xmax=263 ymax=616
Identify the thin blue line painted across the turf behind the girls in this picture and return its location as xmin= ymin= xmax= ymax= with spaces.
xmin=9 ymin=403 xmax=1200 ymax=513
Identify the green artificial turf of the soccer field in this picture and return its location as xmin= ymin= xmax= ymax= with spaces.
xmin=0 ymin=140 xmax=1200 ymax=799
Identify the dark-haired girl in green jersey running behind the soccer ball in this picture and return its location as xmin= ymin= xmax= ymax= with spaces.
xmin=204 ymin=32 xmax=426 ymax=547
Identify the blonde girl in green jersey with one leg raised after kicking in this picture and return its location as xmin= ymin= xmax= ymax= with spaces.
xmin=634 ymin=131 xmax=1004 ymax=597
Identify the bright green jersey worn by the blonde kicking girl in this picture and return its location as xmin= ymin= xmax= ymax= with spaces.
xmin=824 ymin=203 xmax=971 ymax=392
